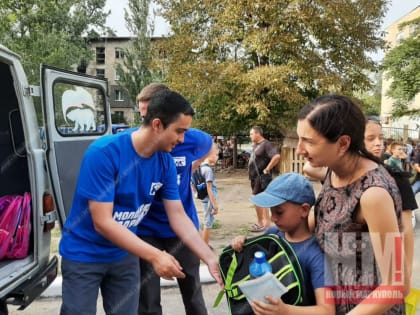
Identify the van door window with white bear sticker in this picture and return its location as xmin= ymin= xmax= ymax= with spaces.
xmin=53 ymin=82 xmax=105 ymax=136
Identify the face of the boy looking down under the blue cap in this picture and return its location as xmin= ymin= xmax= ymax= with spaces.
xmin=270 ymin=201 xmax=308 ymax=233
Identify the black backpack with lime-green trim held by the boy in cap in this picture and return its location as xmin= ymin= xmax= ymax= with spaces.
xmin=213 ymin=234 xmax=307 ymax=315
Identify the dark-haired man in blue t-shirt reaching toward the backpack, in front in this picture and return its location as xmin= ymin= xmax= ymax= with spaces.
xmin=59 ymin=90 xmax=222 ymax=315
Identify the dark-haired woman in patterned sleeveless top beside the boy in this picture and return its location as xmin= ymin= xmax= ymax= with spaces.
xmin=297 ymin=95 xmax=408 ymax=315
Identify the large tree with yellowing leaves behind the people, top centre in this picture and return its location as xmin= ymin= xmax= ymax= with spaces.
xmin=156 ymin=0 xmax=386 ymax=134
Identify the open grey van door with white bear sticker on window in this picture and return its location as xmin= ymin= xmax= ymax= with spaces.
xmin=41 ymin=66 xmax=112 ymax=226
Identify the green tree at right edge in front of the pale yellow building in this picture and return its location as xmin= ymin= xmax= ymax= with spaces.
xmin=382 ymin=18 xmax=420 ymax=117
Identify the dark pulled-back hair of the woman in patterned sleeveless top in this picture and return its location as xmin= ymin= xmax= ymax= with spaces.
xmin=298 ymin=94 xmax=379 ymax=162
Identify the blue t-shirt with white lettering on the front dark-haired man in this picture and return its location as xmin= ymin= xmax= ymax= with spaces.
xmin=59 ymin=129 xmax=180 ymax=263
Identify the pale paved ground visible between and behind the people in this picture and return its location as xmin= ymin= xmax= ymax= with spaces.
xmin=9 ymin=170 xmax=420 ymax=315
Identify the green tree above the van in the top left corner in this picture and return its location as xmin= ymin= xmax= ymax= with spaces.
xmin=0 ymin=0 xmax=109 ymax=83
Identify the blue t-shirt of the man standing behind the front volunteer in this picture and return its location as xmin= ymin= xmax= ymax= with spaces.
xmin=137 ymin=128 xmax=213 ymax=238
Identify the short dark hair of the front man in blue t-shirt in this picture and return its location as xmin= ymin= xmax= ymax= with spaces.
xmin=143 ymin=89 xmax=194 ymax=128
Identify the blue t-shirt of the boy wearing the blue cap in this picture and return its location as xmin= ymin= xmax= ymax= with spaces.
xmin=265 ymin=227 xmax=332 ymax=305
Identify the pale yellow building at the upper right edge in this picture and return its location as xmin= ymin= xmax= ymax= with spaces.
xmin=381 ymin=5 xmax=420 ymax=132
